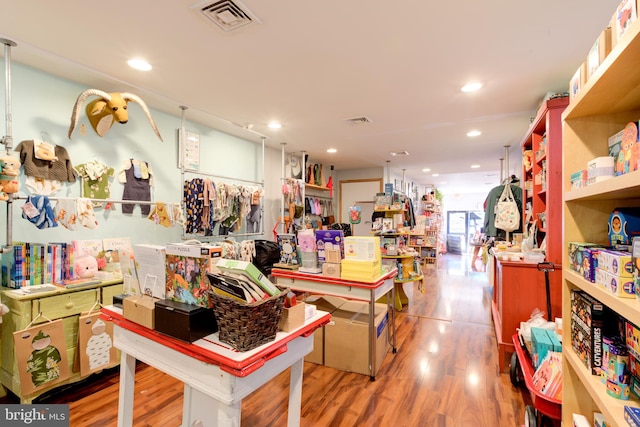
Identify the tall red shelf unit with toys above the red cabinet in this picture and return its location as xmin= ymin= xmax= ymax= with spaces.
xmin=520 ymin=96 xmax=569 ymax=264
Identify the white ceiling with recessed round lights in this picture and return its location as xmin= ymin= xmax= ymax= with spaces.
xmin=0 ymin=0 xmax=618 ymax=193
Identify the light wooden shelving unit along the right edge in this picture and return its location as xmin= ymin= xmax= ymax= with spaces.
xmin=562 ymin=15 xmax=640 ymax=426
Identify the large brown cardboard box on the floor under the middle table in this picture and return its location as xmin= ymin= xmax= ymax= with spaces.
xmin=324 ymin=301 xmax=390 ymax=375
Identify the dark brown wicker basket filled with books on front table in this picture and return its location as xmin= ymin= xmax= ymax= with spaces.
xmin=209 ymin=289 xmax=288 ymax=351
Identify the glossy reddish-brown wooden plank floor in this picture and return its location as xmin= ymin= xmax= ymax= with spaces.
xmin=0 ymin=255 xmax=530 ymax=427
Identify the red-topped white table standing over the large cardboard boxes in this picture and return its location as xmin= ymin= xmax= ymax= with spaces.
xmin=271 ymin=269 xmax=398 ymax=381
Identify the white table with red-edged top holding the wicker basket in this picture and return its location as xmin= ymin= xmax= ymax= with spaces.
xmin=102 ymin=306 xmax=331 ymax=427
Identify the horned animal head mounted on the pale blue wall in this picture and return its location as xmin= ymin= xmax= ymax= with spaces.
xmin=69 ymin=89 xmax=162 ymax=141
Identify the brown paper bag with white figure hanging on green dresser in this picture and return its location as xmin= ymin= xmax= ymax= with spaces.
xmin=78 ymin=311 xmax=118 ymax=377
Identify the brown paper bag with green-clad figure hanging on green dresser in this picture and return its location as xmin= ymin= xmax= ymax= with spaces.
xmin=13 ymin=320 xmax=69 ymax=396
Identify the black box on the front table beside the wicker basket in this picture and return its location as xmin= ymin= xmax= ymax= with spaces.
xmin=154 ymin=299 xmax=218 ymax=343
